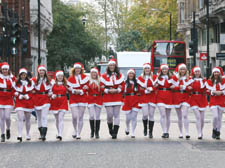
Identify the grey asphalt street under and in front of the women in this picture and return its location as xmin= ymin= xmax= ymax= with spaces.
xmin=0 ymin=109 xmax=225 ymax=168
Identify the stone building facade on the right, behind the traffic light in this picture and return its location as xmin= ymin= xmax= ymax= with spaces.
xmin=177 ymin=0 xmax=225 ymax=73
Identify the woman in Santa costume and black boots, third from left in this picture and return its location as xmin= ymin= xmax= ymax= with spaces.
xmin=32 ymin=65 xmax=51 ymax=141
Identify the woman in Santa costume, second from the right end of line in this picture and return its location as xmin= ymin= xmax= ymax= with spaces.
xmin=189 ymin=66 xmax=208 ymax=140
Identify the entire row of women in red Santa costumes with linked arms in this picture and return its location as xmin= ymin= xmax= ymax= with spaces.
xmin=0 ymin=59 xmax=225 ymax=142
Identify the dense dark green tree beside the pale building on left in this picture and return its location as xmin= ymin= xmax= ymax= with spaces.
xmin=47 ymin=0 xmax=102 ymax=71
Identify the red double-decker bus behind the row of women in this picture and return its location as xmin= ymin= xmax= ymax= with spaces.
xmin=150 ymin=40 xmax=186 ymax=73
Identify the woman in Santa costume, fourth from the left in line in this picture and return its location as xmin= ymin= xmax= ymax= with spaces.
xmin=50 ymin=71 xmax=68 ymax=141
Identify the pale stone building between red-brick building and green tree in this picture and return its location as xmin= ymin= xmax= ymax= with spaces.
xmin=30 ymin=0 xmax=53 ymax=75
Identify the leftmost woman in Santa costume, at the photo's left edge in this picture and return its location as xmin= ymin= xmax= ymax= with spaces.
xmin=0 ymin=62 xmax=15 ymax=142
